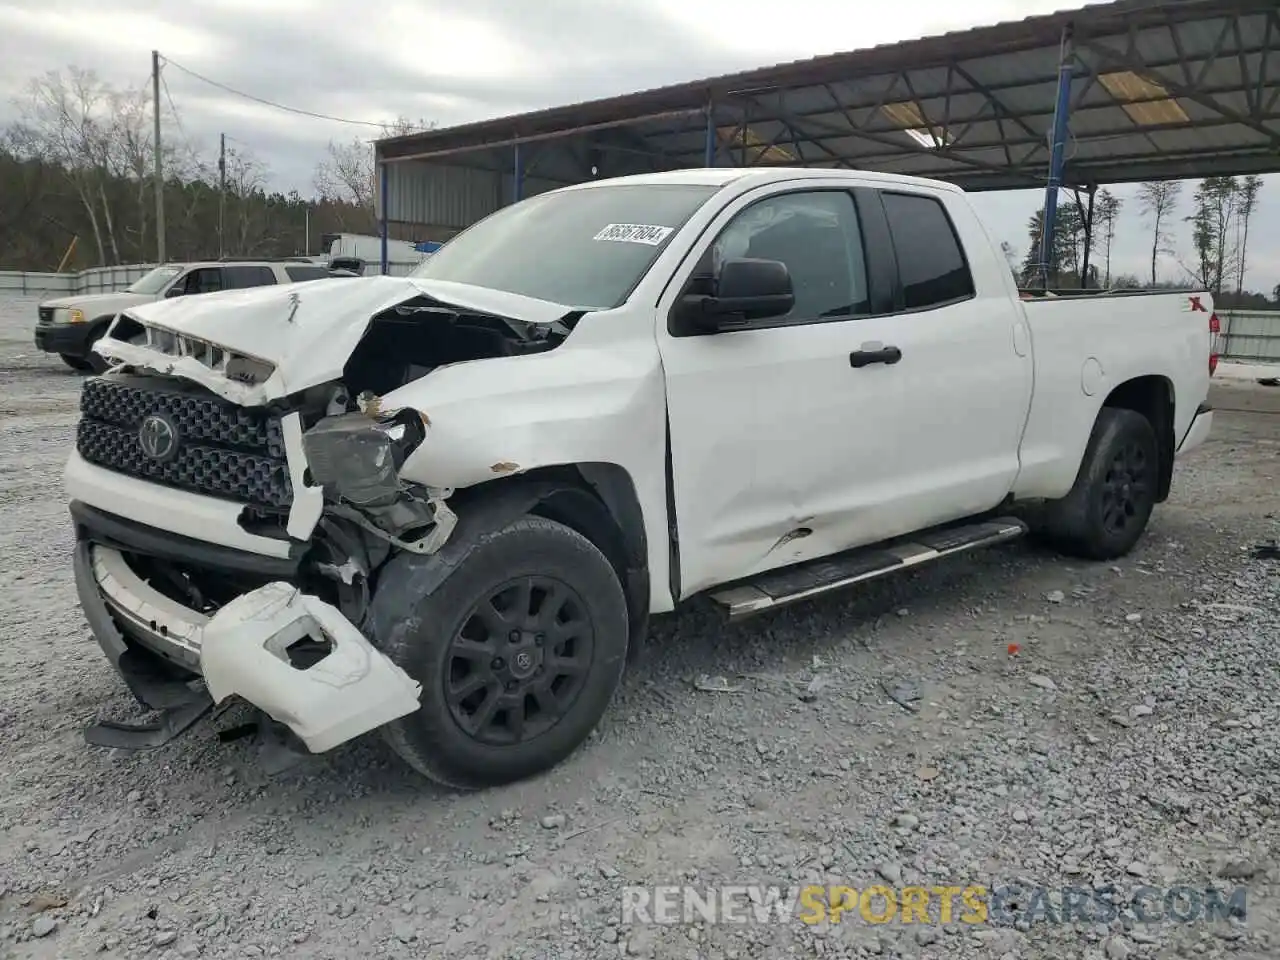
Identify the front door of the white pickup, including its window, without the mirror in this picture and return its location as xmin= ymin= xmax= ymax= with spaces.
xmin=658 ymin=180 xmax=887 ymax=596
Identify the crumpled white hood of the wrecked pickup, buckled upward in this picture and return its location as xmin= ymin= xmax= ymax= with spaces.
xmin=93 ymin=276 xmax=570 ymax=406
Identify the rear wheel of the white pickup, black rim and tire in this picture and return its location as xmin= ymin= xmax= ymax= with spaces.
xmin=1044 ymin=407 xmax=1160 ymax=561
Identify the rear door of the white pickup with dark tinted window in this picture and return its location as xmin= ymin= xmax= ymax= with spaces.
xmin=846 ymin=187 xmax=1032 ymax=543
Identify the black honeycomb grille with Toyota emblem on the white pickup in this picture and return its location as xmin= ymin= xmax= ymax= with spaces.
xmin=76 ymin=378 xmax=293 ymax=508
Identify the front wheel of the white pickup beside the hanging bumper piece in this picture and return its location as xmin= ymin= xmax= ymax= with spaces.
xmin=383 ymin=516 xmax=627 ymax=790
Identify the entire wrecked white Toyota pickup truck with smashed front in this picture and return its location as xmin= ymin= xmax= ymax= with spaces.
xmin=65 ymin=169 xmax=1216 ymax=787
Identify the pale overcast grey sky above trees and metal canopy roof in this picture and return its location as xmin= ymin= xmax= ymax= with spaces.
xmin=0 ymin=0 xmax=1280 ymax=292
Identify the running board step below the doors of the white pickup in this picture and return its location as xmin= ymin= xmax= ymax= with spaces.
xmin=710 ymin=517 xmax=1027 ymax=621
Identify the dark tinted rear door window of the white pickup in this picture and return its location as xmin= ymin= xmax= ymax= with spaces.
xmin=881 ymin=193 xmax=974 ymax=310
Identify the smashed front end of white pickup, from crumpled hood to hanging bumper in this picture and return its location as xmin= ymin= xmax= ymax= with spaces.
xmin=76 ymin=280 xmax=576 ymax=753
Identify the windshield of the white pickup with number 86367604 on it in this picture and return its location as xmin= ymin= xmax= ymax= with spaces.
xmin=411 ymin=183 xmax=718 ymax=310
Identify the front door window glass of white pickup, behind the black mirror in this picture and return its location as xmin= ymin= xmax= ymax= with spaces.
xmin=710 ymin=191 xmax=870 ymax=325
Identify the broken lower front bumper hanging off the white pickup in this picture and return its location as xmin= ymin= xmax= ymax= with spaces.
xmin=74 ymin=511 xmax=421 ymax=753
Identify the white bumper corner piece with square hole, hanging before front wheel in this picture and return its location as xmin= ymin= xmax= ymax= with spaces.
xmin=200 ymin=582 xmax=421 ymax=753
